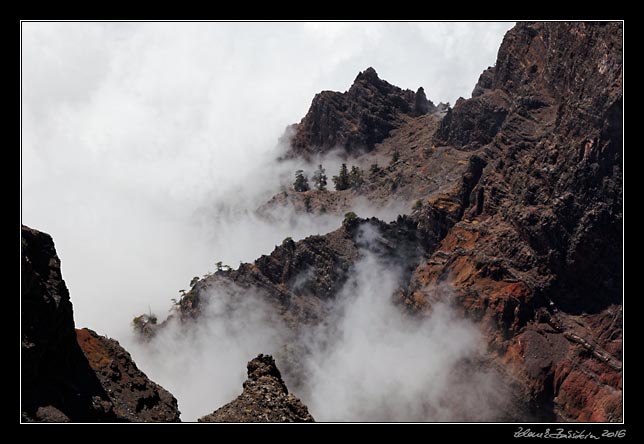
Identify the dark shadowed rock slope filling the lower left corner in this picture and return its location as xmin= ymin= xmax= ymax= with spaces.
xmin=21 ymin=225 xmax=179 ymax=422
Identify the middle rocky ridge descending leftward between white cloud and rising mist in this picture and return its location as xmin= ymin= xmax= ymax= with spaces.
xmin=179 ymin=217 xmax=423 ymax=330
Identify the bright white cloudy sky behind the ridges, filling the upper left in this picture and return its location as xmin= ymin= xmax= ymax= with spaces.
xmin=22 ymin=22 xmax=513 ymax=337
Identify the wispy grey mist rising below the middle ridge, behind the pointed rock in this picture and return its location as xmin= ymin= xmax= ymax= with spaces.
xmin=128 ymin=224 xmax=511 ymax=422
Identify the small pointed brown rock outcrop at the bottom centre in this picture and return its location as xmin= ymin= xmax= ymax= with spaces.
xmin=199 ymin=354 xmax=313 ymax=422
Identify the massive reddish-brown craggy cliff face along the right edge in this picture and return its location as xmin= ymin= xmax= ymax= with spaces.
xmin=408 ymin=23 xmax=623 ymax=421
